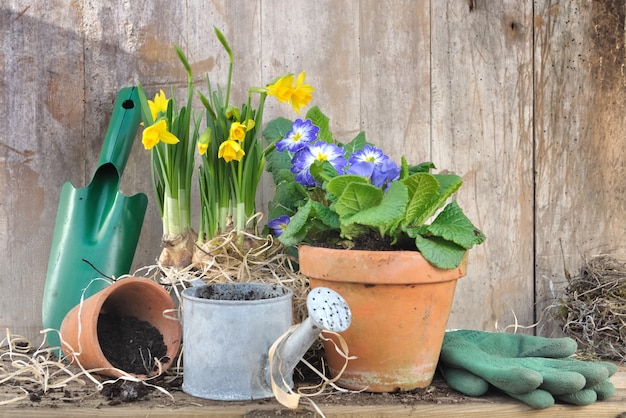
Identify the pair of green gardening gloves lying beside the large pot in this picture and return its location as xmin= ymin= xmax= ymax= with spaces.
xmin=439 ymin=330 xmax=617 ymax=409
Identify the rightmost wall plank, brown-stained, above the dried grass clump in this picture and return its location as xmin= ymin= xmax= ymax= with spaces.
xmin=535 ymin=1 xmax=626 ymax=335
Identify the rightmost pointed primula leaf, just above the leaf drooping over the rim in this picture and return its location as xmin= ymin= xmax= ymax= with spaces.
xmin=426 ymin=201 xmax=485 ymax=249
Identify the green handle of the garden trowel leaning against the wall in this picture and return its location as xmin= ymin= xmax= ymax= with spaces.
xmin=98 ymin=87 xmax=141 ymax=177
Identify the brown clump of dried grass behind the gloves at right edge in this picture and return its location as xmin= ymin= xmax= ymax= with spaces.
xmin=555 ymin=255 xmax=626 ymax=362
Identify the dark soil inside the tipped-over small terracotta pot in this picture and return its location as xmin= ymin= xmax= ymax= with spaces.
xmin=98 ymin=313 xmax=171 ymax=374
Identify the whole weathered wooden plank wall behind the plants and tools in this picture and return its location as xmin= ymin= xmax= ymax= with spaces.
xmin=0 ymin=0 xmax=626 ymax=338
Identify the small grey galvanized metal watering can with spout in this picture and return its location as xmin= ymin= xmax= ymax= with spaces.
xmin=182 ymin=283 xmax=352 ymax=401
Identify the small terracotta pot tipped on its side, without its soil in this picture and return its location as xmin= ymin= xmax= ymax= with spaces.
xmin=61 ymin=277 xmax=182 ymax=378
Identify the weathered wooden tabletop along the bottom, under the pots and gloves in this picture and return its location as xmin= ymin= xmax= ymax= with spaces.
xmin=0 ymin=366 xmax=626 ymax=418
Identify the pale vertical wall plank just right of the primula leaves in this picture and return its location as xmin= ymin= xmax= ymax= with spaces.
xmin=431 ymin=0 xmax=533 ymax=330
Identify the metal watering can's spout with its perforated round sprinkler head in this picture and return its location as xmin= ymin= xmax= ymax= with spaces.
xmin=272 ymin=287 xmax=352 ymax=382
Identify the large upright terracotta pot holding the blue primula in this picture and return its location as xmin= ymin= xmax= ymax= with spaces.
xmin=299 ymin=245 xmax=467 ymax=392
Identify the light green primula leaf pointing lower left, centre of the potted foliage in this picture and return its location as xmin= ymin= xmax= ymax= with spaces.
xmin=344 ymin=182 xmax=409 ymax=234
